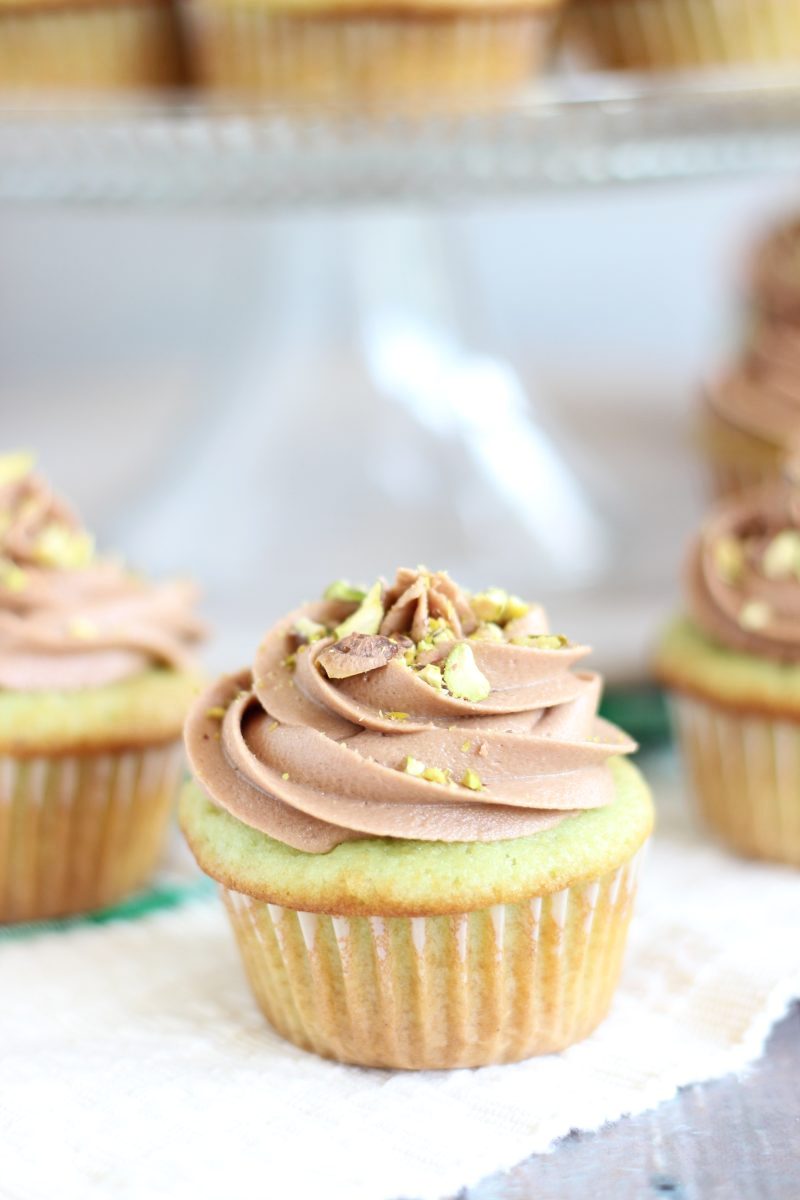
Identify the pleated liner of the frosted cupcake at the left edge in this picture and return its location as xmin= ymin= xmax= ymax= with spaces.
xmin=0 ymin=743 xmax=184 ymax=922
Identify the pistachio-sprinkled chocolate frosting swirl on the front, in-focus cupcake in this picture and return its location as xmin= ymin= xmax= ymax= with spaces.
xmin=186 ymin=569 xmax=636 ymax=853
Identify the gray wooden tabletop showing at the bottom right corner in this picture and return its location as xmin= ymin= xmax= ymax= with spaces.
xmin=455 ymin=1006 xmax=800 ymax=1200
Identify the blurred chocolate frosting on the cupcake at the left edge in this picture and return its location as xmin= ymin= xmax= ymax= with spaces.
xmin=0 ymin=454 xmax=203 ymax=691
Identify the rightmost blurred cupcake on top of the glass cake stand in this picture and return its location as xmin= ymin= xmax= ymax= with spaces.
xmin=569 ymin=0 xmax=800 ymax=70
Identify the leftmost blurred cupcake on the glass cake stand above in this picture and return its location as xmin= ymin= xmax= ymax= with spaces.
xmin=0 ymin=0 xmax=181 ymax=91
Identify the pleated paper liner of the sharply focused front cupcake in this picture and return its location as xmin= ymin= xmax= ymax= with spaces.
xmin=222 ymin=851 xmax=642 ymax=1068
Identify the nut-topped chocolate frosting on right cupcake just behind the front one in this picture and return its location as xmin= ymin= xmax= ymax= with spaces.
xmin=687 ymin=484 xmax=800 ymax=662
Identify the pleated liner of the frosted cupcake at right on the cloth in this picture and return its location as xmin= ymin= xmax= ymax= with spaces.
xmin=673 ymin=696 xmax=800 ymax=866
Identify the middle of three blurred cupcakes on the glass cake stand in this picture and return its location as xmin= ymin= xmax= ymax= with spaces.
xmin=182 ymin=0 xmax=563 ymax=108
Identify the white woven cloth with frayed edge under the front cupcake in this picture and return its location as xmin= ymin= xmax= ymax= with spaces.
xmin=0 ymin=758 xmax=800 ymax=1200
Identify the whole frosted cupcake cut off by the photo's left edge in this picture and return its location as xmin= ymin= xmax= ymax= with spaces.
xmin=0 ymin=455 xmax=201 ymax=922
